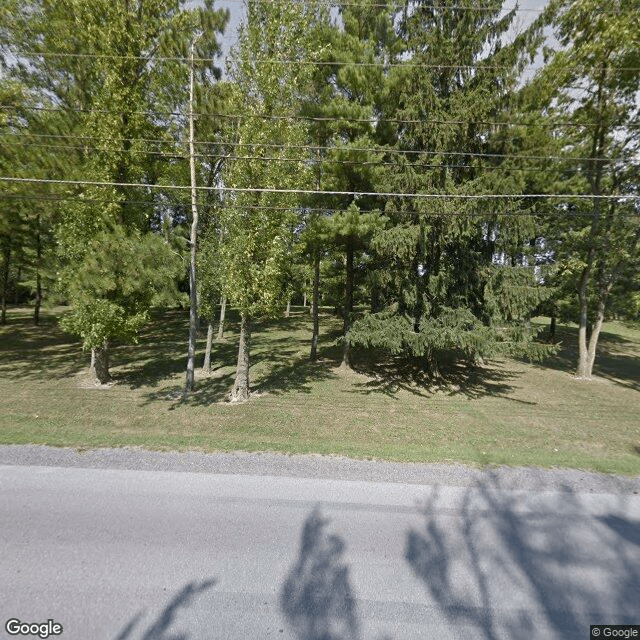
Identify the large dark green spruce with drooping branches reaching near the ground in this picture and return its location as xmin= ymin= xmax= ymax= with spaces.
xmin=342 ymin=0 xmax=545 ymax=375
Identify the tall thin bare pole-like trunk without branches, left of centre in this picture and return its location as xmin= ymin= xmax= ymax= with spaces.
xmin=183 ymin=42 xmax=198 ymax=400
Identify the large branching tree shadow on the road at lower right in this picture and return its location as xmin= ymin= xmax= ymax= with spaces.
xmin=405 ymin=474 xmax=640 ymax=640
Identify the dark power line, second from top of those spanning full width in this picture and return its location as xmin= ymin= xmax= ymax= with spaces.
xmin=0 ymin=105 xmax=640 ymax=128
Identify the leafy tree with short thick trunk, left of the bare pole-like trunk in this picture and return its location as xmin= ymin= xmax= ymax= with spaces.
xmin=2 ymin=0 xmax=226 ymax=381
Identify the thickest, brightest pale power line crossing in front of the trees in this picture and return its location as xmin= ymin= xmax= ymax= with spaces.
xmin=0 ymin=176 xmax=640 ymax=200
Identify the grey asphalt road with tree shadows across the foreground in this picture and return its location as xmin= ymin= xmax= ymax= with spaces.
xmin=0 ymin=448 xmax=640 ymax=640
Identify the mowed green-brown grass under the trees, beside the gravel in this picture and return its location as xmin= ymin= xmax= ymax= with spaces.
xmin=0 ymin=308 xmax=640 ymax=475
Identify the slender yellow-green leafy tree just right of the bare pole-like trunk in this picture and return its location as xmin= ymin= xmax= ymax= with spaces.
xmin=220 ymin=0 xmax=328 ymax=401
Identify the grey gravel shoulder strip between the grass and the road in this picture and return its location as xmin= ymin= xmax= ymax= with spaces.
xmin=0 ymin=445 xmax=640 ymax=494
